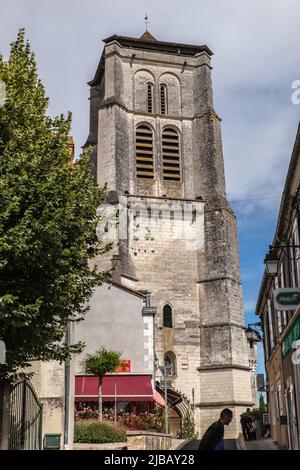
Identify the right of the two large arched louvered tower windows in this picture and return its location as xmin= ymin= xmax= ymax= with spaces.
xmin=162 ymin=128 xmax=180 ymax=181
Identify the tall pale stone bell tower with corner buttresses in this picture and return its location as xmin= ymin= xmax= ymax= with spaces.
xmin=87 ymin=32 xmax=253 ymax=437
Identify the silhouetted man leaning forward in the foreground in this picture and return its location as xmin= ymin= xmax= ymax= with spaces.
xmin=198 ymin=408 xmax=233 ymax=450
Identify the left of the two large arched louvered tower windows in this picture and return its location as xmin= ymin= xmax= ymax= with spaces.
xmin=135 ymin=125 xmax=154 ymax=179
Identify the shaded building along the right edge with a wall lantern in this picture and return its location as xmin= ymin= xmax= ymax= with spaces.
xmin=256 ymin=123 xmax=300 ymax=449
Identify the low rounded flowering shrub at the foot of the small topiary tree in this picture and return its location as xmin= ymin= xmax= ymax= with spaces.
xmin=74 ymin=421 xmax=126 ymax=444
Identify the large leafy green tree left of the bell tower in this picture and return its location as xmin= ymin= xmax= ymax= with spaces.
xmin=0 ymin=29 xmax=109 ymax=379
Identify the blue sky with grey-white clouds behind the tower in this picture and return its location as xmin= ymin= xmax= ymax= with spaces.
xmin=0 ymin=0 xmax=300 ymax=369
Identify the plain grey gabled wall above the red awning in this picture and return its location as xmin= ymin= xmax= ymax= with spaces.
xmin=75 ymin=282 xmax=155 ymax=377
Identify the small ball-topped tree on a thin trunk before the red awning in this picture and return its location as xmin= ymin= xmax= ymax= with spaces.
xmin=83 ymin=348 xmax=122 ymax=421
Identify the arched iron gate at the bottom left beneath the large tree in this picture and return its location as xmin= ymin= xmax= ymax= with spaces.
xmin=9 ymin=380 xmax=43 ymax=450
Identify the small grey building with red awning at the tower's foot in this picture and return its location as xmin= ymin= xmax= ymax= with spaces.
xmin=75 ymin=282 xmax=164 ymax=426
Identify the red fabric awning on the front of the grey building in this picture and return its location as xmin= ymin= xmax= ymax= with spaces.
xmin=75 ymin=374 xmax=156 ymax=402
